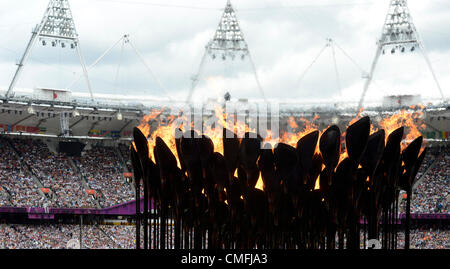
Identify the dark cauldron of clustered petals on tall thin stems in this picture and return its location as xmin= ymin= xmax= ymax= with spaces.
xmin=130 ymin=114 xmax=426 ymax=249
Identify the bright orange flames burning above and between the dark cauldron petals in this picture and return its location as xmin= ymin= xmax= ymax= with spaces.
xmin=138 ymin=105 xmax=426 ymax=190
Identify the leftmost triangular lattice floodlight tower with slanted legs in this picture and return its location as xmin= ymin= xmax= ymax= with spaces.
xmin=6 ymin=0 xmax=94 ymax=100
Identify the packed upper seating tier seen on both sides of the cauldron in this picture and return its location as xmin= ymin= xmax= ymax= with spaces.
xmin=0 ymin=135 xmax=450 ymax=213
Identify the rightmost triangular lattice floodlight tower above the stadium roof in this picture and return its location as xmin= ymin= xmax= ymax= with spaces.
xmin=358 ymin=0 xmax=445 ymax=110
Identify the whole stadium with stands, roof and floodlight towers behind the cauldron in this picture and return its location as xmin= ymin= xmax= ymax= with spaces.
xmin=0 ymin=0 xmax=450 ymax=248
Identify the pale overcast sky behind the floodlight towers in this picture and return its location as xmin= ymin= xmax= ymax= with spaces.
xmin=0 ymin=0 xmax=450 ymax=102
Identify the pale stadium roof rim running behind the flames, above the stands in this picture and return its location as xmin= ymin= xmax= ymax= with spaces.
xmin=0 ymin=92 xmax=450 ymax=139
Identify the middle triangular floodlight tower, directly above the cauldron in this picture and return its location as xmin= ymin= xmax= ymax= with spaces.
xmin=187 ymin=0 xmax=266 ymax=103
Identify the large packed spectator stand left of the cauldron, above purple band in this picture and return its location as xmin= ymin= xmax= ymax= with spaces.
xmin=0 ymin=135 xmax=134 ymax=208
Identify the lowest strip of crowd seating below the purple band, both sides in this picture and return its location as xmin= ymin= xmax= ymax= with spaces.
xmin=0 ymin=224 xmax=450 ymax=249
